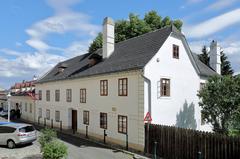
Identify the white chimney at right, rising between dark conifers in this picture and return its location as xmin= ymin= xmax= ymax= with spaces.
xmin=210 ymin=40 xmax=221 ymax=74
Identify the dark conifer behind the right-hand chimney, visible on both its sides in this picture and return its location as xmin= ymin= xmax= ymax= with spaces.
xmin=198 ymin=46 xmax=234 ymax=76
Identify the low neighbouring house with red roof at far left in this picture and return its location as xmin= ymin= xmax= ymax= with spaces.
xmin=10 ymin=80 xmax=36 ymax=122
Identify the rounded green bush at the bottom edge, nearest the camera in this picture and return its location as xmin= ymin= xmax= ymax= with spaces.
xmin=43 ymin=140 xmax=67 ymax=159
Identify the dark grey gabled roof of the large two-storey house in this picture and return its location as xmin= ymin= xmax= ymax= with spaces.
xmin=37 ymin=25 xmax=218 ymax=83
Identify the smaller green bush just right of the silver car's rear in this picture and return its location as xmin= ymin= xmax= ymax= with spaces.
xmin=39 ymin=128 xmax=57 ymax=151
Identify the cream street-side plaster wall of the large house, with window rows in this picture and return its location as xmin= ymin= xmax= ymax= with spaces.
xmin=36 ymin=71 xmax=144 ymax=148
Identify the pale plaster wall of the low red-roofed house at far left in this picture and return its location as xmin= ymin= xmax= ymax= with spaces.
xmin=10 ymin=96 xmax=36 ymax=122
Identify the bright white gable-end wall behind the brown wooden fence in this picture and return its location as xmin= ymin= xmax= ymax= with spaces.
xmin=144 ymin=36 xmax=209 ymax=130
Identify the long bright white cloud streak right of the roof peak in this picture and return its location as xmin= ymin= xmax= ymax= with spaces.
xmin=183 ymin=9 xmax=240 ymax=38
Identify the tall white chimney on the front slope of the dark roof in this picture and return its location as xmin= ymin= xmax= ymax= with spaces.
xmin=103 ymin=17 xmax=115 ymax=58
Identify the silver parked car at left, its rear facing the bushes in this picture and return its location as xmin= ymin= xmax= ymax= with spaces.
xmin=0 ymin=122 xmax=37 ymax=149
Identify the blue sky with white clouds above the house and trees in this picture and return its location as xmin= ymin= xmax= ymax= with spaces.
xmin=0 ymin=0 xmax=240 ymax=89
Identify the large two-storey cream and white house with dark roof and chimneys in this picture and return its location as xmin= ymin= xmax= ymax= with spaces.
xmin=36 ymin=18 xmax=220 ymax=151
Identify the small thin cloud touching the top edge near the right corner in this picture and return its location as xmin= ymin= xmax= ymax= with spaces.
xmin=206 ymin=0 xmax=237 ymax=11
